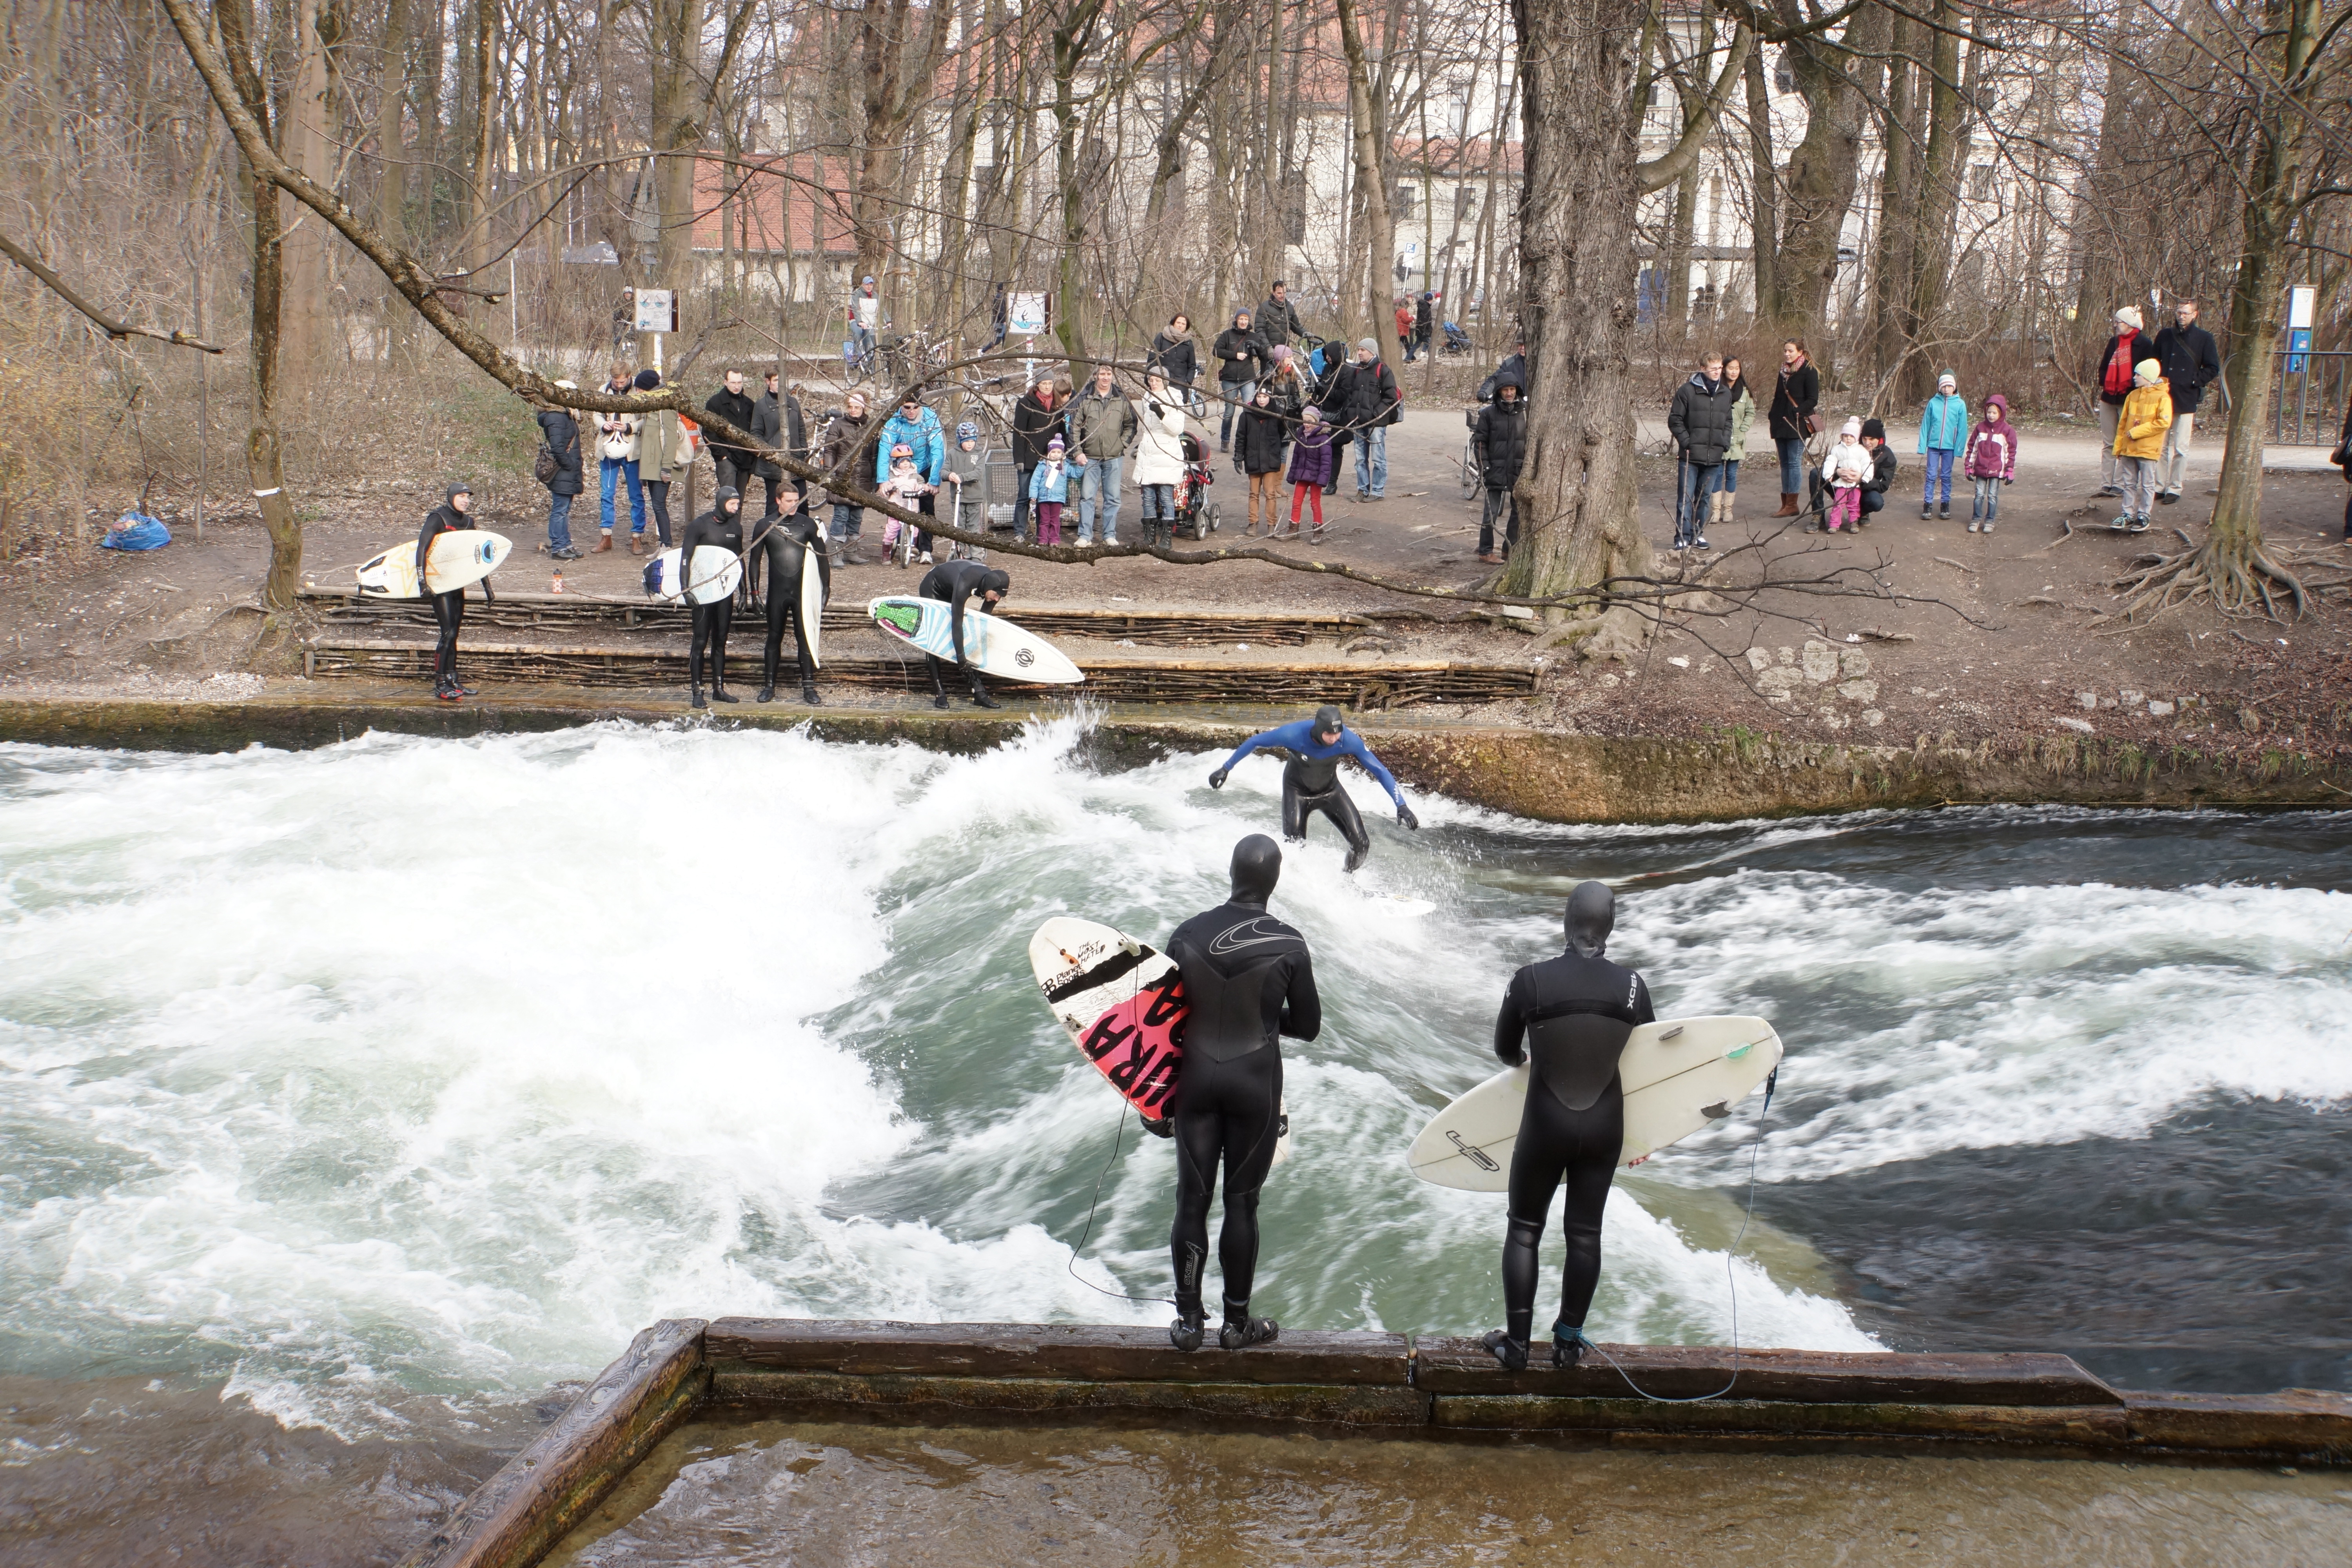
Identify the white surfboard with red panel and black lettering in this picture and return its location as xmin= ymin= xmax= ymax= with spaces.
xmin=1030 ymin=915 xmax=1291 ymax=1166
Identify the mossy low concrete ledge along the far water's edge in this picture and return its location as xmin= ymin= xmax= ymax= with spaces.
xmin=0 ymin=689 xmax=2352 ymax=823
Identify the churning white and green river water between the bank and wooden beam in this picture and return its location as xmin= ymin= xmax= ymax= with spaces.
xmin=0 ymin=722 xmax=2352 ymax=1561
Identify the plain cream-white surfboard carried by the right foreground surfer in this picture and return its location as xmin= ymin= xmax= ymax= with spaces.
xmin=1404 ymin=1016 xmax=1780 ymax=1192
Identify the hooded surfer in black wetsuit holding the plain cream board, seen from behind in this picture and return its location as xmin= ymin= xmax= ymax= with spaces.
xmin=1484 ymin=882 xmax=1656 ymax=1370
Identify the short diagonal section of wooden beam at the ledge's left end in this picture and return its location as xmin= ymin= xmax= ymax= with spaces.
xmin=400 ymin=1316 xmax=710 ymax=1568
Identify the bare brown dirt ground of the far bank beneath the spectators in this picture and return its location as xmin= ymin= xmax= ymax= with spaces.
xmin=0 ymin=407 xmax=2352 ymax=757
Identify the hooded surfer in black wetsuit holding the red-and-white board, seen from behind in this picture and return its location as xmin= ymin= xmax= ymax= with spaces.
xmin=1145 ymin=832 xmax=1322 ymax=1349
